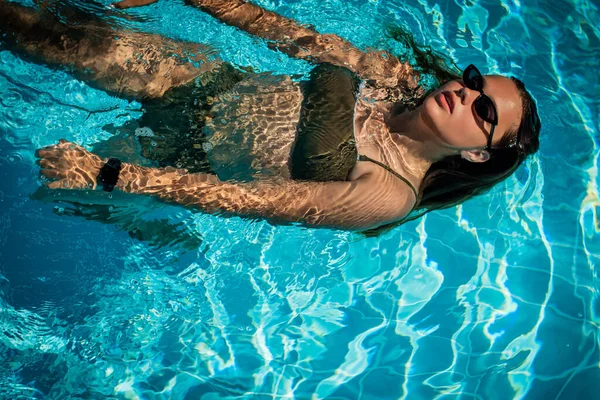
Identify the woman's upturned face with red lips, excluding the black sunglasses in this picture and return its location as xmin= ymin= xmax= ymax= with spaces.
xmin=421 ymin=75 xmax=521 ymax=155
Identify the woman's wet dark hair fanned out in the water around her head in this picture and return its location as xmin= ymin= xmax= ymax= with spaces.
xmin=365 ymin=26 xmax=542 ymax=236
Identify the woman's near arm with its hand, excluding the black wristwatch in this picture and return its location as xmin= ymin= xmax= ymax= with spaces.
xmin=37 ymin=140 xmax=412 ymax=230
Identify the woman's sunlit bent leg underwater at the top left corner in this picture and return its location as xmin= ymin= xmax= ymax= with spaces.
xmin=0 ymin=0 xmax=221 ymax=99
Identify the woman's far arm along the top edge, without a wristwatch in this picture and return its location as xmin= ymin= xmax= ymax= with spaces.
xmin=115 ymin=0 xmax=418 ymax=88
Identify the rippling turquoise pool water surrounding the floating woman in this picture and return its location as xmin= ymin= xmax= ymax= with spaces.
xmin=0 ymin=0 xmax=600 ymax=399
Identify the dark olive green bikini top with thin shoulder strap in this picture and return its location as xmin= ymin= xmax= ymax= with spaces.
xmin=290 ymin=64 xmax=418 ymax=202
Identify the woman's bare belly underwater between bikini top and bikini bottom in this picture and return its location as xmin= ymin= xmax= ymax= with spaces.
xmin=204 ymin=74 xmax=302 ymax=180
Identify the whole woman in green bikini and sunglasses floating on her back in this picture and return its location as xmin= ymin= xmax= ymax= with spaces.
xmin=0 ymin=0 xmax=540 ymax=230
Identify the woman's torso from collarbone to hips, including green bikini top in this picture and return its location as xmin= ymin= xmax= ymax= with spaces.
xmin=136 ymin=65 xmax=422 ymax=186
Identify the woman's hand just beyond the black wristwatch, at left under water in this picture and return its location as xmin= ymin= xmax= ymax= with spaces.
xmin=36 ymin=139 xmax=104 ymax=189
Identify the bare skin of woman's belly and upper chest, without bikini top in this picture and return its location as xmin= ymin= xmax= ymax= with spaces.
xmin=204 ymin=70 xmax=402 ymax=184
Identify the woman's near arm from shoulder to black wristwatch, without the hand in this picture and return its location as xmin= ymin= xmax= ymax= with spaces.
xmin=117 ymin=164 xmax=410 ymax=230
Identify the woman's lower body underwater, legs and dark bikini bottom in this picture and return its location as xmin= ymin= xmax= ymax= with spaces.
xmin=0 ymin=0 xmax=241 ymax=170
